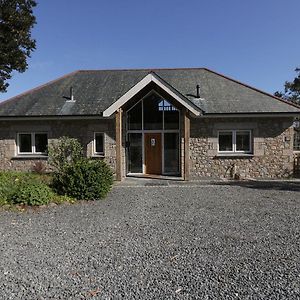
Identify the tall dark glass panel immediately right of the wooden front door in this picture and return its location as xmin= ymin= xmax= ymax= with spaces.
xmin=164 ymin=132 xmax=179 ymax=174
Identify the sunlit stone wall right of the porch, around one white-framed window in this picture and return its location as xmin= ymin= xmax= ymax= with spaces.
xmin=190 ymin=117 xmax=293 ymax=179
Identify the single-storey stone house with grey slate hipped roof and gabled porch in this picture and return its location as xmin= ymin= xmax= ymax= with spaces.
xmin=0 ymin=68 xmax=300 ymax=180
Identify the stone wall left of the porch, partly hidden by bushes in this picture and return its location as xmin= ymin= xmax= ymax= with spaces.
xmin=0 ymin=120 xmax=116 ymax=171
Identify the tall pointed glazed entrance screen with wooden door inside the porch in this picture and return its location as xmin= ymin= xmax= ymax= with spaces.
xmin=126 ymin=90 xmax=181 ymax=176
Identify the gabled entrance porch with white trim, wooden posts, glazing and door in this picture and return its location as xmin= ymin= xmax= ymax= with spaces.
xmin=103 ymin=72 xmax=202 ymax=180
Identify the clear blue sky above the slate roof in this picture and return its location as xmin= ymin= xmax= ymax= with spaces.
xmin=0 ymin=0 xmax=300 ymax=100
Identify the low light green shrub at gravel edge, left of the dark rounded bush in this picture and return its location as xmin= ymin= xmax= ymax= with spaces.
xmin=10 ymin=182 xmax=53 ymax=206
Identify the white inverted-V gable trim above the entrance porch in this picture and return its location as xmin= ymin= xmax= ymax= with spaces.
xmin=103 ymin=74 xmax=200 ymax=117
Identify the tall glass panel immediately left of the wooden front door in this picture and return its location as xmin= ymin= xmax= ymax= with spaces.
xmin=128 ymin=133 xmax=143 ymax=173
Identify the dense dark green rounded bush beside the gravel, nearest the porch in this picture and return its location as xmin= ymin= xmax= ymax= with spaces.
xmin=53 ymin=159 xmax=113 ymax=200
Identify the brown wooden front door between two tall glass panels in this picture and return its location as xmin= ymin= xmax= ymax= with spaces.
xmin=145 ymin=133 xmax=162 ymax=175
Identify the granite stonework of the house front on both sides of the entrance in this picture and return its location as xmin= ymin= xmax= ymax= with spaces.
xmin=0 ymin=117 xmax=294 ymax=179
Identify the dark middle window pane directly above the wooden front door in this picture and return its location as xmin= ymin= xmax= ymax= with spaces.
xmin=143 ymin=94 xmax=163 ymax=129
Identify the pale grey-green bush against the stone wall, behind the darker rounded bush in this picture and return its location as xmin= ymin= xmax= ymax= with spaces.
xmin=48 ymin=136 xmax=83 ymax=173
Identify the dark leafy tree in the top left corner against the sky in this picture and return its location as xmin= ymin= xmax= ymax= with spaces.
xmin=0 ymin=0 xmax=36 ymax=92
